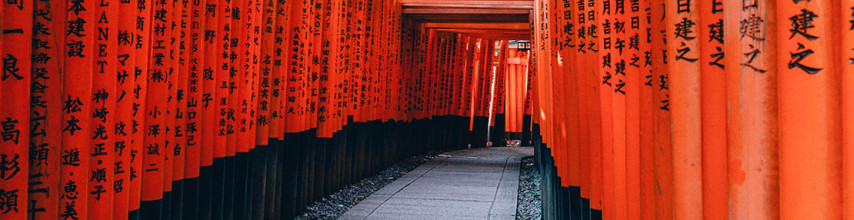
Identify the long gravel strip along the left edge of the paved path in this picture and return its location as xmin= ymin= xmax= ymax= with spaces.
xmin=296 ymin=154 xmax=436 ymax=220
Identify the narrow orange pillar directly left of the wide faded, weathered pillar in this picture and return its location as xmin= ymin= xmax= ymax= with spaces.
xmin=697 ymin=0 xmax=727 ymax=219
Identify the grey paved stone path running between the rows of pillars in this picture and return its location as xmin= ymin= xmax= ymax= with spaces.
xmin=340 ymin=147 xmax=534 ymax=220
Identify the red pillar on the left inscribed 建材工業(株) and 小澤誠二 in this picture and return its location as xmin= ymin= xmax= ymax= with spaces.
xmin=140 ymin=0 xmax=171 ymax=210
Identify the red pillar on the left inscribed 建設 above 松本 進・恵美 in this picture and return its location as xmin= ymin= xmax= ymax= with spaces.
xmin=60 ymin=0 xmax=96 ymax=219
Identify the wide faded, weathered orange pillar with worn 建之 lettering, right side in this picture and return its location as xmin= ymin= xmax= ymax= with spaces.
xmin=723 ymin=1 xmax=785 ymax=219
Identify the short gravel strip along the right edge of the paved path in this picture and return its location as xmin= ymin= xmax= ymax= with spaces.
xmin=516 ymin=157 xmax=543 ymax=219
